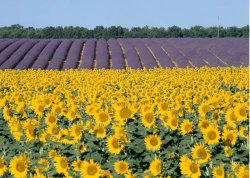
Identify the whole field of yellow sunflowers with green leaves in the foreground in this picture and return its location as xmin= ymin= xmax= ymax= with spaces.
xmin=0 ymin=67 xmax=249 ymax=178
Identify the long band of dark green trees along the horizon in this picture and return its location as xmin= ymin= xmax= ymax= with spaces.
xmin=0 ymin=24 xmax=249 ymax=39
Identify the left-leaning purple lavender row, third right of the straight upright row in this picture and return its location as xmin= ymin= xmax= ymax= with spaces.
xmin=129 ymin=39 xmax=157 ymax=69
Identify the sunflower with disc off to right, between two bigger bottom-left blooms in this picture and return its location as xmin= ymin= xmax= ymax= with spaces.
xmin=54 ymin=156 xmax=69 ymax=175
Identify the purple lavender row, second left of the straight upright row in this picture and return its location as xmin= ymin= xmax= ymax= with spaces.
xmin=63 ymin=39 xmax=85 ymax=70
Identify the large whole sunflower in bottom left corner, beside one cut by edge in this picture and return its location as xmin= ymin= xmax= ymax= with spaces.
xmin=9 ymin=156 xmax=29 ymax=177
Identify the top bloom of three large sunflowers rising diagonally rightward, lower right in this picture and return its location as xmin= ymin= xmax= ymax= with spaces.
xmin=203 ymin=126 xmax=220 ymax=145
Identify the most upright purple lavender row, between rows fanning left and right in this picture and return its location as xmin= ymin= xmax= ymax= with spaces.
xmin=96 ymin=39 xmax=109 ymax=69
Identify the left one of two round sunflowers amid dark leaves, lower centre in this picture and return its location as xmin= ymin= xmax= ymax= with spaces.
xmin=107 ymin=135 xmax=124 ymax=154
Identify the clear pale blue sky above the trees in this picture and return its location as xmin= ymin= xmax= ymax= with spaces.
xmin=0 ymin=0 xmax=249 ymax=29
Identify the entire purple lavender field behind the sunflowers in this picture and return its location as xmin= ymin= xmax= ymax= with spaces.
xmin=0 ymin=38 xmax=249 ymax=70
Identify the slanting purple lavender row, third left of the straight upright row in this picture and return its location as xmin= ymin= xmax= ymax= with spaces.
xmin=47 ymin=40 xmax=72 ymax=70
